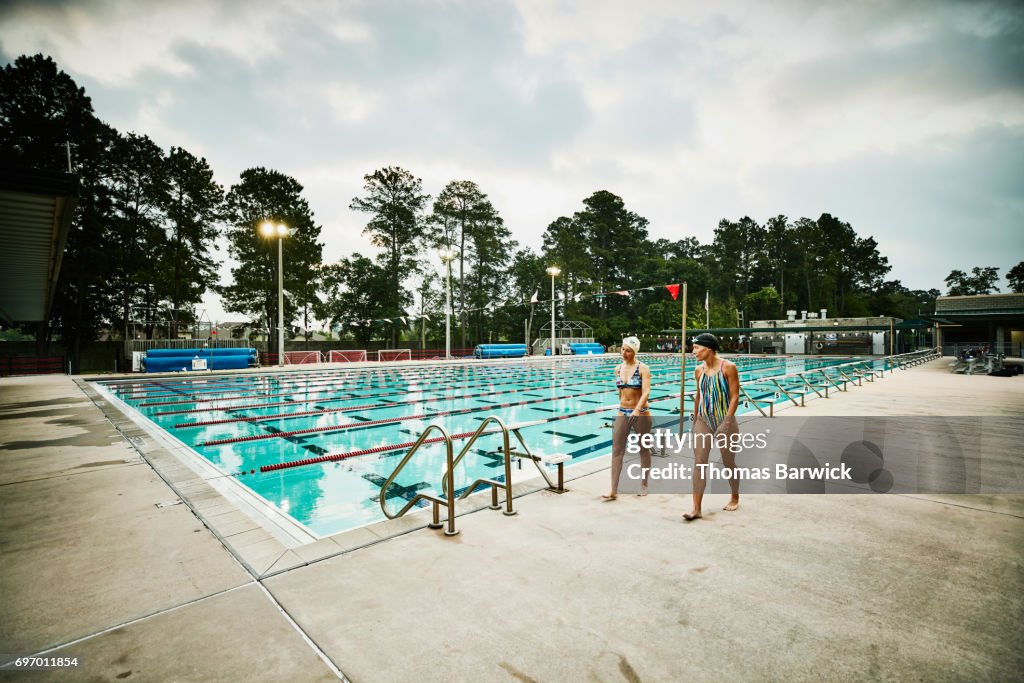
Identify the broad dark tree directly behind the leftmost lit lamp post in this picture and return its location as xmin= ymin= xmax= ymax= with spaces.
xmin=217 ymin=167 xmax=324 ymax=352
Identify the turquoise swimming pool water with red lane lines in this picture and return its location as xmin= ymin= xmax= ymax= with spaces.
xmin=97 ymin=355 xmax=884 ymax=537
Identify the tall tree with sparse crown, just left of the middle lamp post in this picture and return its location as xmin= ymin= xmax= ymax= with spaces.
xmin=349 ymin=166 xmax=430 ymax=345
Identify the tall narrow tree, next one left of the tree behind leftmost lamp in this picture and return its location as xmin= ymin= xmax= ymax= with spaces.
xmin=158 ymin=147 xmax=224 ymax=336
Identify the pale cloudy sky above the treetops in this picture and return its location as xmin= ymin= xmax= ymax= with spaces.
xmin=0 ymin=0 xmax=1024 ymax=319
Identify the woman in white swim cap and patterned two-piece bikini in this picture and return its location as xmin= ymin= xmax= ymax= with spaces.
xmin=601 ymin=337 xmax=652 ymax=501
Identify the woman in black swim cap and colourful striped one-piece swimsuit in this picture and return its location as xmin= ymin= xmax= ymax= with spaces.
xmin=683 ymin=332 xmax=739 ymax=521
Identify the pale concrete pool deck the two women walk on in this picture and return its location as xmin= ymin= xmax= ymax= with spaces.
xmin=0 ymin=359 xmax=1024 ymax=682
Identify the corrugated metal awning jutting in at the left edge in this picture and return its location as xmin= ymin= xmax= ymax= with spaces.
xmin=0 ymin=164 xmax=79 ymax=325
